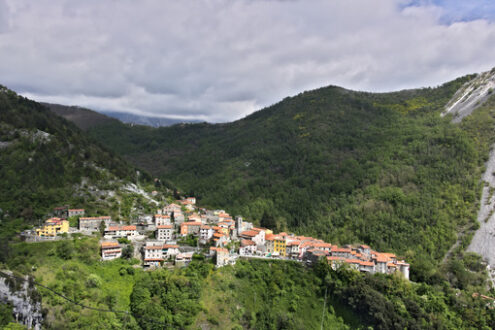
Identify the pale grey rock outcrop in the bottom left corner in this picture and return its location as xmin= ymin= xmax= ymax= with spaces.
xmin=0 ymin=271 xmax=43 ymax=330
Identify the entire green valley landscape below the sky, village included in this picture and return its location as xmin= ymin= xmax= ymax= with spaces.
xmin=0 ymin=69 xmax=495 ymax=329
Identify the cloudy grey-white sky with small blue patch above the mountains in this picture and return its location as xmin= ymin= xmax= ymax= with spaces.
xmin=0 ymin=0 xmax=495 ymax=122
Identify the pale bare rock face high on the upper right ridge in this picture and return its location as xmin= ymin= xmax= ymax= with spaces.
xmin=442 ymin=70 xmax=495 ymax=123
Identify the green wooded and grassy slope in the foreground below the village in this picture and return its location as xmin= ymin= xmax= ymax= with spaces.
xmin=0 ymin=236 xmax=495 ymax=330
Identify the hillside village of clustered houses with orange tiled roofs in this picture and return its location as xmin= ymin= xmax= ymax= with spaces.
xmin=31 ymin=197 xmax=409 ymax=279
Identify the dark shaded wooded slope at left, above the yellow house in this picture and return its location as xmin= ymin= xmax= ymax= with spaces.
xmin=0 ymin=86 xmax=145 ymax=242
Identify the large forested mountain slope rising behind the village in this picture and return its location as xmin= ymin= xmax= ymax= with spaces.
xmin=84 ymin=76 xmax=493 ymax=279
